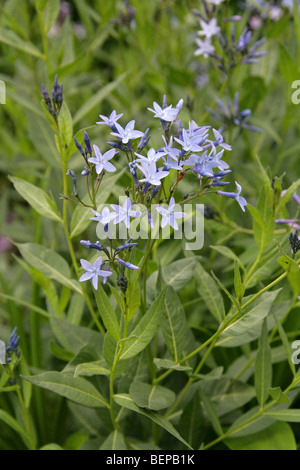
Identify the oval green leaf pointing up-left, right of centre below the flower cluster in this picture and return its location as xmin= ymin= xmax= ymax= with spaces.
xmin=195 ymin=263 xmax=225 ymax=323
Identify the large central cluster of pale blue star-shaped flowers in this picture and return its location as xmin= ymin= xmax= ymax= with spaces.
xmin=74 ymin=96 xmax=247 ymax=290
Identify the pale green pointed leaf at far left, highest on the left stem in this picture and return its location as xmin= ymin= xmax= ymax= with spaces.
xmin=9 ymin=176 xmax=62 ymax=222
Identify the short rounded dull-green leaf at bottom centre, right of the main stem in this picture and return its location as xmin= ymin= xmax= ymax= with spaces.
xmin=129 ymin=380 xmax=176 ymax=411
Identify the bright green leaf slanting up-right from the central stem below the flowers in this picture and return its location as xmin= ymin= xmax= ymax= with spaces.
xmin=120 ymin=288 xmax=167 ymax=359
